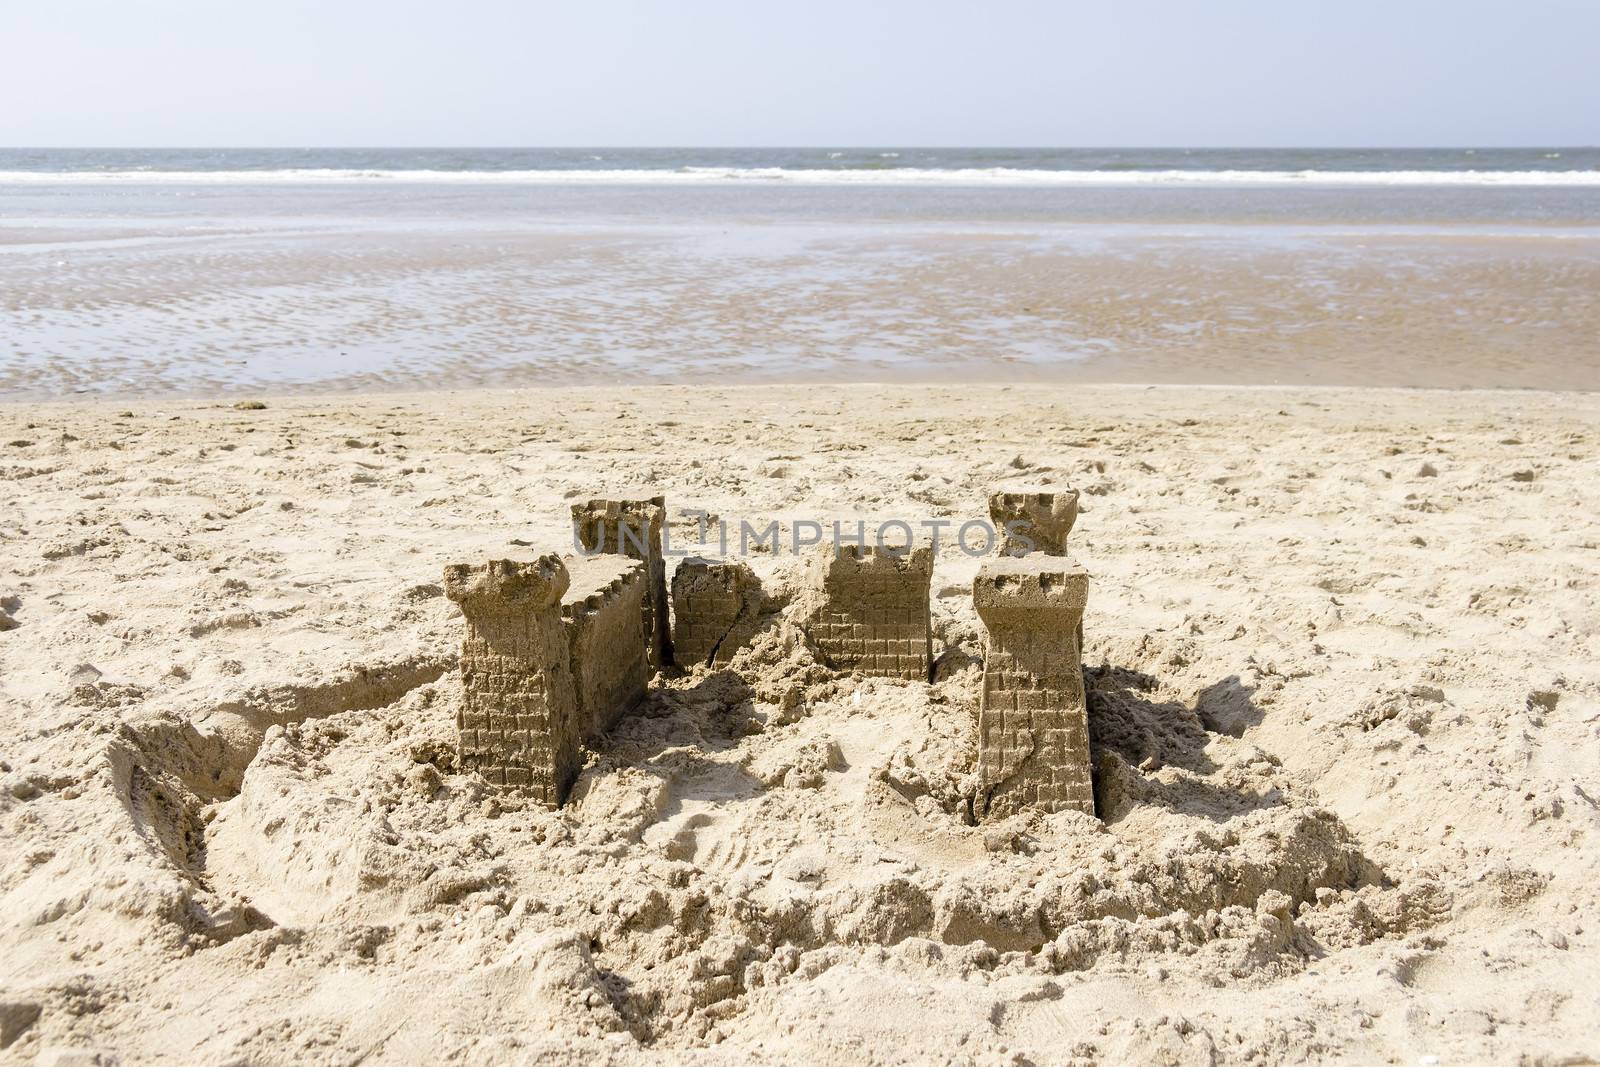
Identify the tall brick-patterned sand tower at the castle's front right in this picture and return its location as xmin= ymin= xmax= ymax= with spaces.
xmin=973 ymin=553 xmax=1094 ymax=817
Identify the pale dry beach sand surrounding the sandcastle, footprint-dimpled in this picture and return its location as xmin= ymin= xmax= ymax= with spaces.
xmin=0 ymin=386 xmax=1600 ymax=1064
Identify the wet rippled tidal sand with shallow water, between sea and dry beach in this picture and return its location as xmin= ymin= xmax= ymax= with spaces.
xmin=0 ymin=197 xmax=1600 ymax=398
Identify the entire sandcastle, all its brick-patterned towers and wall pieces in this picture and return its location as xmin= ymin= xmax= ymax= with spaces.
xmin=445 ymin=490 xmax=1094 ymax=817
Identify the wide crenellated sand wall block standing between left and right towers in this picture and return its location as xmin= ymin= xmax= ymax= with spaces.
xmin=803 ymin=544 xmax=933 ymax=681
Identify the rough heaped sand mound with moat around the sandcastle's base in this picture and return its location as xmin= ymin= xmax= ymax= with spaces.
xmin=0 ymin=614 xmax=1450 ymax=1046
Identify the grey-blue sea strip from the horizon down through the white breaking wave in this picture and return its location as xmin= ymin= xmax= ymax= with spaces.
xmin=0 ymin=146 xmax=1600 ymax=186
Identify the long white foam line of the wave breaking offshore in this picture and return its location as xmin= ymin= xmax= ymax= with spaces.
xmin=0 ymin=166 xmax=1600 ymax=187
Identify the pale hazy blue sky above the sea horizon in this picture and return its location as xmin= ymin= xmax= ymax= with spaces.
xmin=0 ymin=0 xmax=1600 ymax=146
